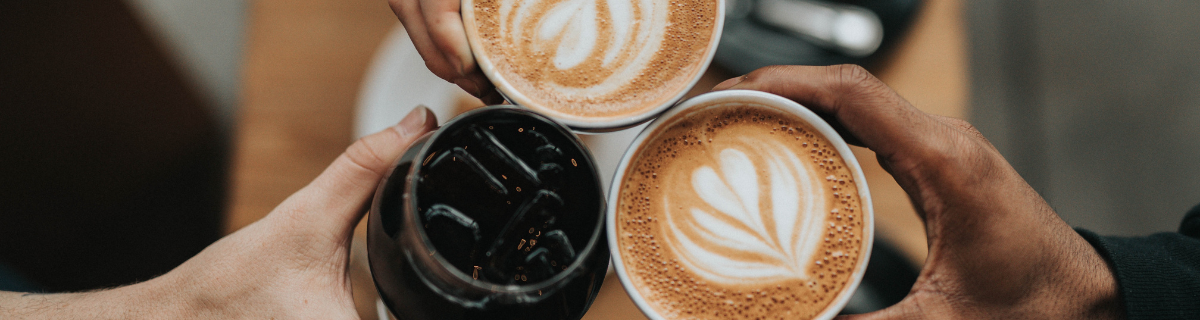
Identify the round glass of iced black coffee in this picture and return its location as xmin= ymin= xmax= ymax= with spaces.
xmin=367 ymin=107 xmax=610 ymax=320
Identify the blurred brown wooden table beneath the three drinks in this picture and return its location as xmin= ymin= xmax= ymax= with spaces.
xmin=226 ymin=0 xmax=968 ymax=319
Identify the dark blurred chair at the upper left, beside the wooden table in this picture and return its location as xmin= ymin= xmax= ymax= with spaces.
xmin=0 ymin=0 xmax=227 ymax=291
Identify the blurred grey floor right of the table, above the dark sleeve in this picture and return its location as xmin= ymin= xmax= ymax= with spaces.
xmin=966 ymin=0 xmax=1200 ymax=235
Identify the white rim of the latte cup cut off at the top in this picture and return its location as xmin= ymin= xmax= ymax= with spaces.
xmin=460 ymin=0 xmax=725 ymax=133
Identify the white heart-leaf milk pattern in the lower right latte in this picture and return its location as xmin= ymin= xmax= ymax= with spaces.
xmin=664 ymin=144 xmax=827 ymax=284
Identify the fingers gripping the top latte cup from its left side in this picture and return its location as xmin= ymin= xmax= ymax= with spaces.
xmin=388 ymin=0 xmax=504 ymax=104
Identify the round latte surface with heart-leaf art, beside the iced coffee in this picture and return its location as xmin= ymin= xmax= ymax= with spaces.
xmin=616 ymin=103 xmax=869 ymax=319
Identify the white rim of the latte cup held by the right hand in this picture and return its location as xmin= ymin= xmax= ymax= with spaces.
xmin=605 ymin=90 xmax=875 ymax=320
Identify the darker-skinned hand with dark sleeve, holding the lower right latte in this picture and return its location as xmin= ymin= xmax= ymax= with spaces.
xmin=714 ymin=66 xmax=1123 ymax=319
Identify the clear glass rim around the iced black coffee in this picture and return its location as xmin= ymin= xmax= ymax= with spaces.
xmin=402 ymin=105 xmax=607 ymax=296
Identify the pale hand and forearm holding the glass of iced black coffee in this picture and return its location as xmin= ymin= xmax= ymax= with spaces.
xmin=0 ymin=108 xmax=437 ymax=319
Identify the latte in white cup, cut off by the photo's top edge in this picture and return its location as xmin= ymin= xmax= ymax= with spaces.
xmin=462 ymin=0 xmax=722 ymax=128
